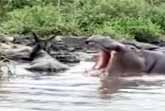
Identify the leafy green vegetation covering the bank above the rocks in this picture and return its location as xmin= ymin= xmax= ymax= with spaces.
xmin=0 ymin=0 xmax=165 ymax=39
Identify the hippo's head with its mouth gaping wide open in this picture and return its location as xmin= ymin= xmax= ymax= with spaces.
xmin=86 ymin=36 xmax=143 ymax=74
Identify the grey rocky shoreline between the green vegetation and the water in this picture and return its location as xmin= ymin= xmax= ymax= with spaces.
xmin=0 ymin=35 xmax=164 ymax=79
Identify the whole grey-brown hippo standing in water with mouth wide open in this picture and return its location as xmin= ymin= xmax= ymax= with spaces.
xmin=85 ymin=36 xmax=165 ymax=76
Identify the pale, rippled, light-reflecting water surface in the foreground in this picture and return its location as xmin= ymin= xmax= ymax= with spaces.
xmin=0 ymin=63 xmax=165 ymax=111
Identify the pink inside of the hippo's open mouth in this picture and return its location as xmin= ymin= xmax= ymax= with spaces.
xmin=93 ymin=50 xmax=111 ymax=70
